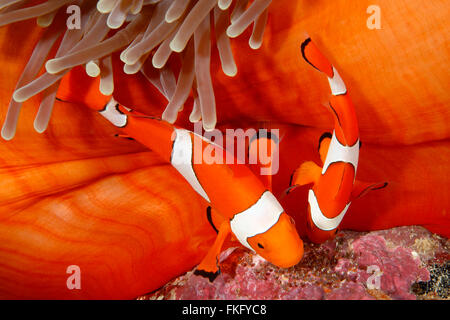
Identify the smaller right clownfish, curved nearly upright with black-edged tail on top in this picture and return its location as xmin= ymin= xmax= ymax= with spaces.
xmin=288 ymin=38 xmax=387 ymax=243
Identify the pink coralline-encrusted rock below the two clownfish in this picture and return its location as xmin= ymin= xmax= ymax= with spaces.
xmin=139 ymin=226 xmax=450 ymax=300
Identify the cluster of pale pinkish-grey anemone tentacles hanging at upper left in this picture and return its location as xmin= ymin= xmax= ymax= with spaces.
xmin=0 ymin=0 xmax=271 ymax=140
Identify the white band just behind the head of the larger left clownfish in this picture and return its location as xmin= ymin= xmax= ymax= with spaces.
xmin=230 ymin=191 xmax=284 ymax=252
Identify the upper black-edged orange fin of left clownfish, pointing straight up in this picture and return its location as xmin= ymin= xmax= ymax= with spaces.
xmin=247 ymin=130 xmax=280 ymax=192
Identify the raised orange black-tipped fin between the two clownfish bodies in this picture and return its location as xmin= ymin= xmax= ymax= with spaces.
xmin=247 ymin=129 xmax=279 ymax=191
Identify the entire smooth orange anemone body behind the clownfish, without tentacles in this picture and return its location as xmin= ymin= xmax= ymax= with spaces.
xmin=0 ymin=0 xmax=450 ymax=298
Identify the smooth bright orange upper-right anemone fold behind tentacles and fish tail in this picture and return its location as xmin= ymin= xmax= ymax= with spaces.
xmin=88 ymin=0 xmax=450 ymax=146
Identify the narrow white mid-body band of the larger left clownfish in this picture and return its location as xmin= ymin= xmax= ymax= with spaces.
xmin=170 ymin=129 xmax=211 ymax=202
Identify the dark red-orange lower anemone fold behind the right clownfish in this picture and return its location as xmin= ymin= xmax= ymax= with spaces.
xmin=248 ymin=124 xmax=450 ymax=239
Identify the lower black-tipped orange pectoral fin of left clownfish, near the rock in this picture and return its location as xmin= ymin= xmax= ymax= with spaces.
xmin=194 ymin=221 xmax=231 ymax=282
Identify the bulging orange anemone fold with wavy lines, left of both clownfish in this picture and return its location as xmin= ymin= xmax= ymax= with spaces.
xmin=0 ymin=21 xmax=220 ymax=299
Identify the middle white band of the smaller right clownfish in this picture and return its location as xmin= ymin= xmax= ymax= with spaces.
xmin=322 ymin=131 xmax=359 ymax=176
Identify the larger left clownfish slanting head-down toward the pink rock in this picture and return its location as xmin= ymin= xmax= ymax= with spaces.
xmin=81 ymin=98 xmax=303 ymax=281
